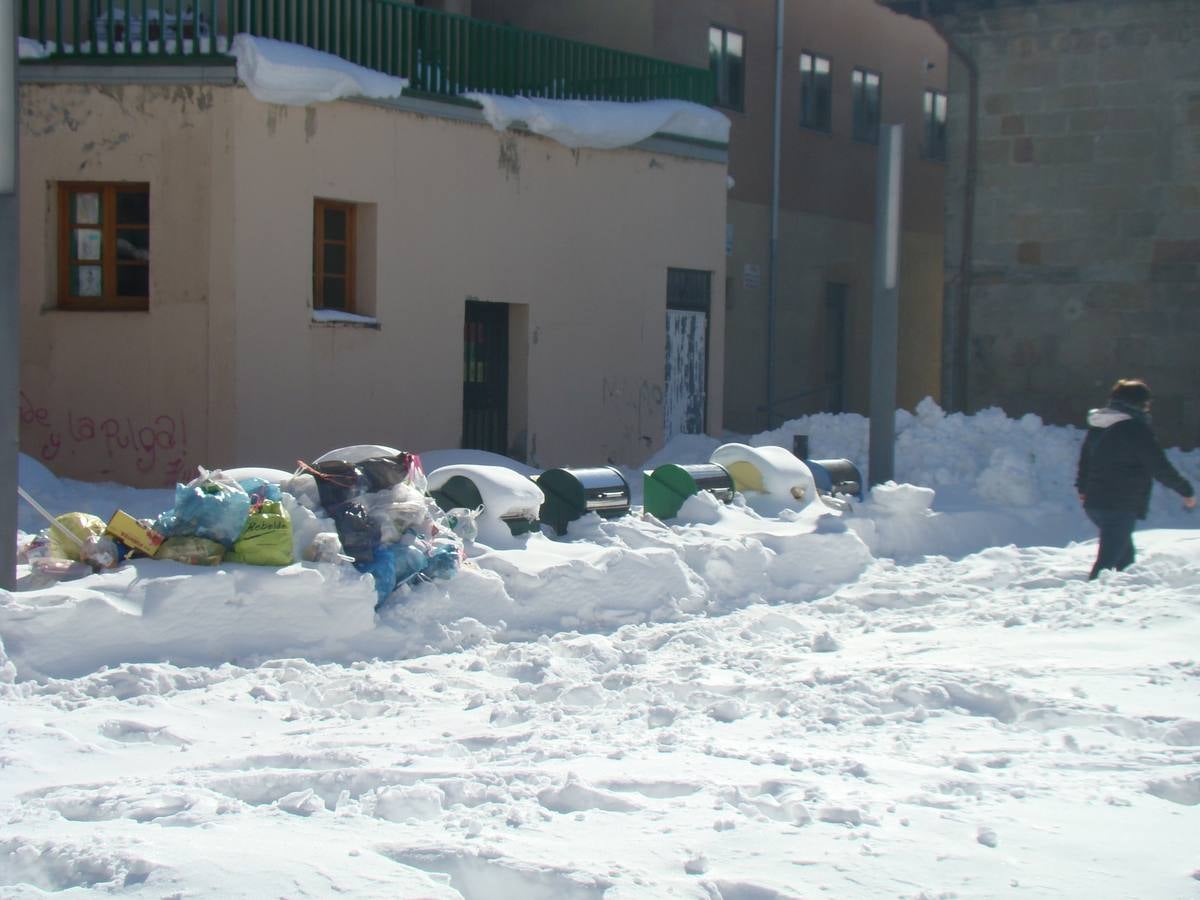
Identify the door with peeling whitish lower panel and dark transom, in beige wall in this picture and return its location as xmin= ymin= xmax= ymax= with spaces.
xmin=662 ymin=269 xmax=710 ymax=440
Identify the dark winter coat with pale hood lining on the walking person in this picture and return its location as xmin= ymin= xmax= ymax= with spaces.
xmin=1075 ymin=406 xmax=1193 ymax=518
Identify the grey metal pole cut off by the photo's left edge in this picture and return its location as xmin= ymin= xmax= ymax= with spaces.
xmin=0 ymin=0 xmax=20 ymax=590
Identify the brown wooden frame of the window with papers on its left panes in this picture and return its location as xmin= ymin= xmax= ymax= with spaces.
xmin=58 ymin=181 xmax=150 ymax=312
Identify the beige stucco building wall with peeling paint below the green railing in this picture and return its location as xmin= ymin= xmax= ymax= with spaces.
xmin=19 ymin=65 xmax=727 ymax=485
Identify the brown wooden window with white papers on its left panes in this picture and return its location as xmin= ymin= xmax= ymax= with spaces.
xmin=58 ymin=181 xmax=150 ymax=311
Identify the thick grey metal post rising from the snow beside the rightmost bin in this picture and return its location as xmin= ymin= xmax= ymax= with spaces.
xmin=869 ymin=125 xmax=904 ymax=485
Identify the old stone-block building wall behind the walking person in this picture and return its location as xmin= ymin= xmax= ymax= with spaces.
xmin=880 ymin=0 xmax=1200 ymax=448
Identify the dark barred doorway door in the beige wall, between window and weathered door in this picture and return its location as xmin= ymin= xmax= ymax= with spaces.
xmin=462 ymin=300 xmax=509 ymax=454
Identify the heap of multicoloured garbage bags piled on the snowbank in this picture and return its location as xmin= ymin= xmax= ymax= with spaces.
xmin=20 ymin=451 xmax=476 ymax=608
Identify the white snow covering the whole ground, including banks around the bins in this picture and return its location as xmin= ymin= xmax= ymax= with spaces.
xmin=0 ymin=401 xmax=1200 ymax=900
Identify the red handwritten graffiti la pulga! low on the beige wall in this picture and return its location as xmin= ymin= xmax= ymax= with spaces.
xmin=20 ymin=391 xmax=187 ymax=485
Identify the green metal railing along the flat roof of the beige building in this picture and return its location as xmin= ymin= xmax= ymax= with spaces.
xmin=18 ymin=0 xmax=715 ymax=104
